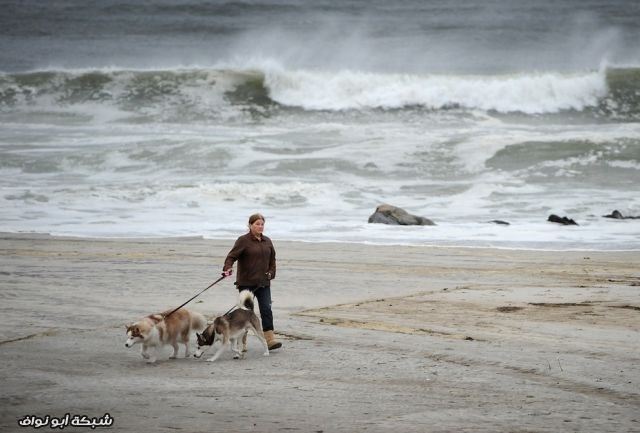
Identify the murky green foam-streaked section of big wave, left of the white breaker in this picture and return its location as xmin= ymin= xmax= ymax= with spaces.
xmin=0 ymin=69 xmax=263 ymax=122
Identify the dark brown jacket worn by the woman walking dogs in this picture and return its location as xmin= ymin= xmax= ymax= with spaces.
xmin=222 ymin=233 xmax=276 ymax=287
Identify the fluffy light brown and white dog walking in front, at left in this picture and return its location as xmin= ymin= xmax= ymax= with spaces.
xmin=124 ymin=308 xmax=207 ymax=363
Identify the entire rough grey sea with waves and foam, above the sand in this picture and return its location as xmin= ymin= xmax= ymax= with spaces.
xmin=0 ymin=0 xmax=640 ymax=250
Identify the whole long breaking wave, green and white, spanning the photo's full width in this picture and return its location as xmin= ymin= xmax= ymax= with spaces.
xmin=0 ymin=65 xmax=640 ymax=121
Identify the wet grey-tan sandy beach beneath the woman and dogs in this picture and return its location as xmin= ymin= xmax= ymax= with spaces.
xmin=0 ymin=234 xmax=640 ymax=433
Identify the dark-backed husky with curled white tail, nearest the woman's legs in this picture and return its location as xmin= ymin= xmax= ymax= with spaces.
xmin=193 ymin=290 xmax=269 ymax=362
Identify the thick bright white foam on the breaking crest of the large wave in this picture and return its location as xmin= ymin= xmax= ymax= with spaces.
xmin=265 ymin=68 xmax=607 ymax=114
